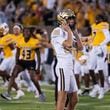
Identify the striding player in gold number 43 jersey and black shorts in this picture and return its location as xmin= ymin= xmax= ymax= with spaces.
xmin=1 ymin=27 xmax=45 ymax=101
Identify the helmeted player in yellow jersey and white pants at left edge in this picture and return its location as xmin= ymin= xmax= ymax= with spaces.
xmin=0 ymin=23 xmax=24 ymax=99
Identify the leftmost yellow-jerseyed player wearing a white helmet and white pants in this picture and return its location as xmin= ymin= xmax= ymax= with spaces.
xmin=0 ymin=23 xmax=15 ymax=85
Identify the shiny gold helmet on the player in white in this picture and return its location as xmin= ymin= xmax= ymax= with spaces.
xmin=57 ymin=9 xmax=75 ymax=24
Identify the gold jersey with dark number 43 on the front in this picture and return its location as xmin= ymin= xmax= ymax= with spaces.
xmin=16 ymin=37 xmax=40 ymax=61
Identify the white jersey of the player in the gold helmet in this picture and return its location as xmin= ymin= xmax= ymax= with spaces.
xmin=51 ymin=27 xmax=75 ymax=68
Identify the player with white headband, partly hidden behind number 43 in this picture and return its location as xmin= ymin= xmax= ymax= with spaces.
xmin=12 ymin=23 xmax=38 ymax=99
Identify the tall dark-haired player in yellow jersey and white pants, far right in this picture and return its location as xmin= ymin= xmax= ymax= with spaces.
xmin=89 ymin=14 xmax=110 ymax=99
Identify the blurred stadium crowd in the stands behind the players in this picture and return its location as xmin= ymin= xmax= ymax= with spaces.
xmin=0 ymin=0 xmax=110 ymax=26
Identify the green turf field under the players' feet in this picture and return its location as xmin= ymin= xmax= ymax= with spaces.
xmin=0 ymin=86 xmax=110 ymax=110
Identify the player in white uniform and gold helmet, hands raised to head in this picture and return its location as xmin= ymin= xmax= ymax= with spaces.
xmin=51 ymin=9 xmax=82 ymax=110
